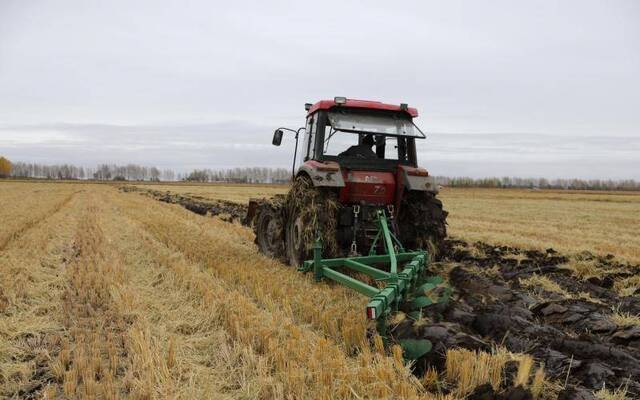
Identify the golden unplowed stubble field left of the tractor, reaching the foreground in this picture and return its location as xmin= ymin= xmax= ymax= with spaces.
xmin=0 ymin=183 xmax=432 ymax=399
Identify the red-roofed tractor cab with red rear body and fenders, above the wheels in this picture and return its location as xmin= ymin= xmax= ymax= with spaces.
xmin=273 ymin=97 xmax=436 ymax=206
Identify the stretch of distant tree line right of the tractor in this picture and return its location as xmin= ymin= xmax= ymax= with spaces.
xmin=436 ymin=176 xmax=640 ymax=191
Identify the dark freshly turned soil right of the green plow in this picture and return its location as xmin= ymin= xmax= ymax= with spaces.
xmin=395 ymin=240 xmax=640 ymax=398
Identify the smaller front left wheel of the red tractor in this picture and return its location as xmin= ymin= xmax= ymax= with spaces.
xmin=253 ymin=199 xmax=285 ymax=259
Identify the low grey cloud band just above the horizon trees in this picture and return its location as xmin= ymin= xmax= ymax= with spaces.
xmin=0 ymin=121 xmax=640 ymax=179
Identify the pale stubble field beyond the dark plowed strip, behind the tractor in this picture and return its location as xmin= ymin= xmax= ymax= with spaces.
xmin=136 ymin=184 xmax=640 ymax=263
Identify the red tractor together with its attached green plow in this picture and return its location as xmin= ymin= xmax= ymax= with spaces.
xmin=247 ymin=97 xmax=447 ymax=354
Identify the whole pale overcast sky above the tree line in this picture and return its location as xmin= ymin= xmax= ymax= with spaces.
xmin=0 ymin=0 xmax=640 ymax=179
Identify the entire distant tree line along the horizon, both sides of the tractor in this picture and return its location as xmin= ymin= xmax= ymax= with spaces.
xmin=0 ymin=157 xmax=640 ymax=191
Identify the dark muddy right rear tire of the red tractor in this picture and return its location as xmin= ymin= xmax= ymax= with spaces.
xmin=398 ymin=191 xmax=449 ymax=259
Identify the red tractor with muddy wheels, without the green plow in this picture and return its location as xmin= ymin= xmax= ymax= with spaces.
xmin=247 ymin=97 xmax=447 ymax=266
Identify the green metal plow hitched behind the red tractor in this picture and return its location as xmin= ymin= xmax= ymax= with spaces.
xmin=300 ymin=210 xmax=451 ymax=360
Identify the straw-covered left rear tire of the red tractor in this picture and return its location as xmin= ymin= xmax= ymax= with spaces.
xmin=285 ymin=176 xmax=339 ymax=267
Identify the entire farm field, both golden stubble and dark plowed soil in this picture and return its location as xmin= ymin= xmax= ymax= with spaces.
xmin=0 ymin=182 xmax=640 ymax=399
